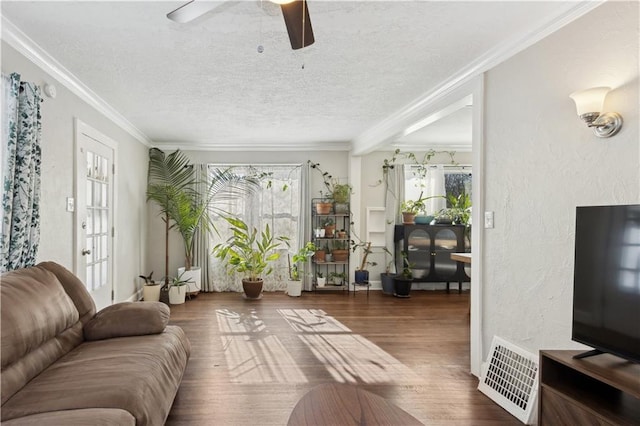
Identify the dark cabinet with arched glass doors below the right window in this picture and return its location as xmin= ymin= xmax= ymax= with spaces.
xmin=394 ymin=225 xmax=471 ymax=291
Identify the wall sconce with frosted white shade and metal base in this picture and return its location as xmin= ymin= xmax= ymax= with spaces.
xmin=569 ymin=87 xmax=622 ymax=138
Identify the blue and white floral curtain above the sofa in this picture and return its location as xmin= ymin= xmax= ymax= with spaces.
xmin=0 ymin=73 xmax=42 ymax=272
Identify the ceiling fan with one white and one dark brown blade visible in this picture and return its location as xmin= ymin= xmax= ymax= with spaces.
xmin=167 ymin=0 xmax=315 ymax=50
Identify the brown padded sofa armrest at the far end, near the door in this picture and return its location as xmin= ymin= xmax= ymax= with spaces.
xmin=84 ymin=302 xmax=170 ymax=340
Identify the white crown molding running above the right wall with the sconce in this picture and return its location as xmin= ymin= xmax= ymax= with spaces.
xmin=352 ymin=0 xmax=606 ymax=155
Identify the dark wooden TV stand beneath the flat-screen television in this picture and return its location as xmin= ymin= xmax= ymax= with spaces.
xmin=538 ymin=350 xmax=640 ymax=426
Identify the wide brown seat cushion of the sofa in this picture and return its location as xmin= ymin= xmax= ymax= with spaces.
xmin=2 ymin=326 xmax=190 ymax=425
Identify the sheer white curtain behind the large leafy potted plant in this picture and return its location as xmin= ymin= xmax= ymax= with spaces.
xmin=206 ymin=164 xmax=306 ymax=292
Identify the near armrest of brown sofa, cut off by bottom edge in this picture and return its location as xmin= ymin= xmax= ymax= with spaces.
xmin=2 ymin=408 xmax=136 ymax=426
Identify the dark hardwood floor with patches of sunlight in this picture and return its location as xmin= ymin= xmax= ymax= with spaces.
xmin=167 ymin=291 xmax=520 ymax=425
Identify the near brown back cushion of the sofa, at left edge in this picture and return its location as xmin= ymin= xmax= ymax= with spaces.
xmin=0 ymin=267 xmax=83 ymax=404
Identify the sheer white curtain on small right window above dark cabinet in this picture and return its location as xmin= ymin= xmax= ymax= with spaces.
xmin=404 ymin=164 xmax=447 ymax=214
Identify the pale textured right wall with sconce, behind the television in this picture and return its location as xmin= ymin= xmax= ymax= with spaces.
xmin=482 ymin=2 xmax=640 ymax=358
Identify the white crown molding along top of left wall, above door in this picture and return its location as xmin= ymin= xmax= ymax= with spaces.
xmin=2 ymin=16 xmax=153 ymax=146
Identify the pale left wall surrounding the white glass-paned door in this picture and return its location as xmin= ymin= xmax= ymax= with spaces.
xmin=2 ymin=42 xmax=147 ymax=301
